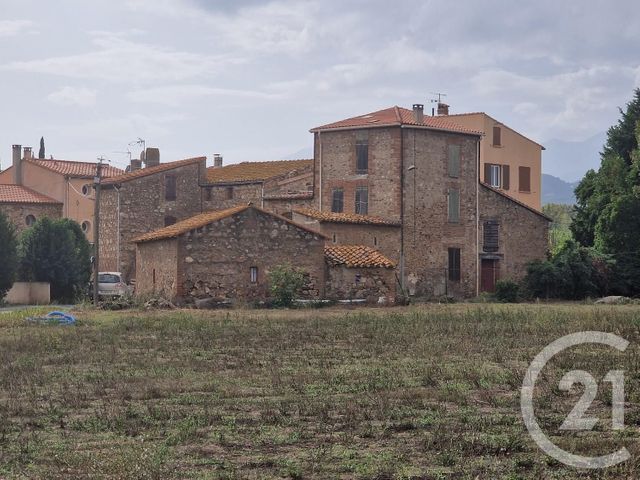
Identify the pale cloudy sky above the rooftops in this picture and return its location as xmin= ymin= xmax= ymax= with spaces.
xmin=0 ymin=0 xmax=640 ymax=180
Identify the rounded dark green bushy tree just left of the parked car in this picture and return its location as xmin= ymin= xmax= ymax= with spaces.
xmin=20 ymin=217 xmax=91 ymax=301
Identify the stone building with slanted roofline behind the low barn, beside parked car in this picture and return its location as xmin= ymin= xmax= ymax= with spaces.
xmin=99 ymin=157 xmax=206 ymax=281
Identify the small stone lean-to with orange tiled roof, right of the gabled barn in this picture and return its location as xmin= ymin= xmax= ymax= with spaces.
xmin=324 ymin=245 xmax=398 ymax=303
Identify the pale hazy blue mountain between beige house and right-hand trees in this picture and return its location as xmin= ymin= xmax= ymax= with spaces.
xmin=542 ymin=132 xmax=607 ymax=181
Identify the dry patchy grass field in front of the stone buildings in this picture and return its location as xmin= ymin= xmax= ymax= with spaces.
xmin=0 ymin=305 xmax=640 ymax=479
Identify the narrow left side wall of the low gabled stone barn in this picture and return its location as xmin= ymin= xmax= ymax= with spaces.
xmin=136 ymin=238 xmax=178 ymax=299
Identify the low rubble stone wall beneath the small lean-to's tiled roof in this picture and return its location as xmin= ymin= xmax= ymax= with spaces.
xmin=326 ymin=265 xmax=397 ymax=303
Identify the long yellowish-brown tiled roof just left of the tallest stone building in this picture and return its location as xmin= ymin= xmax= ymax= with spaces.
xmin=207 ymin=159 xmax=313 ymax=183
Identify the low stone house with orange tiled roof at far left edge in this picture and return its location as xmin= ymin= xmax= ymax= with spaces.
xmin=0 ymin=184 xmax=62 ymax=234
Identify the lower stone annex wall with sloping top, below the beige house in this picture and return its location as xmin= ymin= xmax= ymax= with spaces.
xmin=478 ymin=185 xmax=549 ymax=280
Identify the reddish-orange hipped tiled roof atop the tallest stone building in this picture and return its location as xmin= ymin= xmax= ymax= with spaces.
xmin=311 ymin=106 xmax=482 ymax=135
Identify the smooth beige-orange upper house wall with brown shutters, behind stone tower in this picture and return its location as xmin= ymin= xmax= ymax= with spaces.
xmin=442 ymin=113 xmax=542 ymax=210
